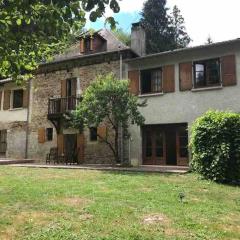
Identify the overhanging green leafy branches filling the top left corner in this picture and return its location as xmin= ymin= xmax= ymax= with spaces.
xmin=0 ymin=0 xmax=120 ymax=83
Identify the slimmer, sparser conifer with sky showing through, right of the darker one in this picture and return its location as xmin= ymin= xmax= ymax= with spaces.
xmin=170 ymin=5 xmax=191 ymax=49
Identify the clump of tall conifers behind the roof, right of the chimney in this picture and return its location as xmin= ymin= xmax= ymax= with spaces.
xmin=141 ymin=0 xmax=190 ymax=54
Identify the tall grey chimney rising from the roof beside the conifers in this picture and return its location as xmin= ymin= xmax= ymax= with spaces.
xmin=131 ymin=22 xmax=146 ymax=56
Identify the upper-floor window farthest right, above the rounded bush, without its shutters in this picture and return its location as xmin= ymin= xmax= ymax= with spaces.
xmin=194 ymin=59 xmax=220 ymax=88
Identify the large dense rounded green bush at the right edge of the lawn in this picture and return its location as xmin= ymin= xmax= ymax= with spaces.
xmin=190 ymin=111 xmax=240 ymax=183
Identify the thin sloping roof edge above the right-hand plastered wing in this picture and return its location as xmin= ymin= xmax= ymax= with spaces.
xmin=126 ymin=38 xmax=240 ymax=62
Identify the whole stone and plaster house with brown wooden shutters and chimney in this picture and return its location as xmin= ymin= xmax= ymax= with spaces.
xmin=0 ymin=24 xmax=240 ymax=165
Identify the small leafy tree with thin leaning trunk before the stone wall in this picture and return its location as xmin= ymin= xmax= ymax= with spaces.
xmin=70 ymin=73 xmax=146 ymax=163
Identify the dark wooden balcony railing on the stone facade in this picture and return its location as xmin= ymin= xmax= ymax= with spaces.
xmin=48 ymin=97 xmax=81 ymax=116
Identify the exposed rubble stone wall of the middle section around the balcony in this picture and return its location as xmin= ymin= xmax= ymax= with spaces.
xmin=28 ymin=61 xmax=120 ymax=163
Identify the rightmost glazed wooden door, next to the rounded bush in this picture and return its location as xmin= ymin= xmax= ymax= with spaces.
xmin=176 ymin=126 xmax=188 ymax=166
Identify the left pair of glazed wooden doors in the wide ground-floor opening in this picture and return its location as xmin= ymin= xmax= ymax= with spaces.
xmin=143 ymin=126 xmax=166 ymax=165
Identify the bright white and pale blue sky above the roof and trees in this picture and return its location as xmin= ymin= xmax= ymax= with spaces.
xmin=86 ymin=0 xmax=240 ymax=46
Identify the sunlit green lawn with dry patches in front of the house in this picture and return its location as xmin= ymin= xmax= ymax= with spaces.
xmin=0 ymin=166 xmax=240 ymax=240
